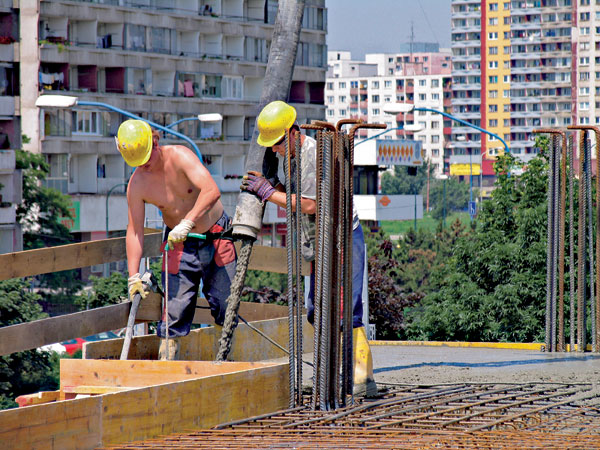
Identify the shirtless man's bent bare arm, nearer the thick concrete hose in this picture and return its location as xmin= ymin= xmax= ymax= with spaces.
xmin=176 ymin=147 xmax=221 ymax=223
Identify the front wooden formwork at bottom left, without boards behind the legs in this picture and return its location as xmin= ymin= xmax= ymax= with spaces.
xmin=0 ymin=359 xmax=289 ymax=449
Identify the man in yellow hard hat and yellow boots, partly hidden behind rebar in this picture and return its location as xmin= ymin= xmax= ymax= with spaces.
xmin=241 ymin=101 xmax=377 ymax=396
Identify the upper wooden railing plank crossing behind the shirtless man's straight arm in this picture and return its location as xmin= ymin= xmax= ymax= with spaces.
xmin=0 ymin=231 xmax=161 ymax=280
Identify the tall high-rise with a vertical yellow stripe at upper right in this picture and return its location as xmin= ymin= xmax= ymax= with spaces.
xmin=452 ymin=0 xmax=584 ymax=160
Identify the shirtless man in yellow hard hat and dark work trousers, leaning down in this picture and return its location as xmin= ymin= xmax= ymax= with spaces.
xmin=116 ymin=120 xmax=236 ymax=360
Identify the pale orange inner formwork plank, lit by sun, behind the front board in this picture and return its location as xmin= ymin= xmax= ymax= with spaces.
xmin=60 ymin=359 xmax=273 ymax=386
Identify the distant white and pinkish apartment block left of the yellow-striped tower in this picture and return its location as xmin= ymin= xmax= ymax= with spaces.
xmin=325 ymin=48 xmax=451 ymax=175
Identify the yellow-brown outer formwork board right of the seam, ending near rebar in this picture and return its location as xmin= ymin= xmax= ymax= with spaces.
xmin=101 ymin=364 xmax=289 ymax=446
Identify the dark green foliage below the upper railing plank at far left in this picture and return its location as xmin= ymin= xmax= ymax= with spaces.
xmin=0 ymin=279 xmax=58 ymax=409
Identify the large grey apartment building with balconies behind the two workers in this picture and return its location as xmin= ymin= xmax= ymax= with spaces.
xmin=19 ymin=0 xmax=327 ymax=258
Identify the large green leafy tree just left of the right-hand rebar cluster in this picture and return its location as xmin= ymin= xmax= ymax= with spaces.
xmin=408 ymin=140 xmax=548 ymax=342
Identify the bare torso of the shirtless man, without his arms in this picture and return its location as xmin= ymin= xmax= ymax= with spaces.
xmin=131 ymin=145 xmax=223 ymax=233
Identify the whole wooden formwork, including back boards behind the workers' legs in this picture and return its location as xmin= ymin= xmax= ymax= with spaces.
xmin=0 ymin=318 xmax=312 ymax=449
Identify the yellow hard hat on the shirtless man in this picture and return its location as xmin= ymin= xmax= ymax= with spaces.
xmin=115 ymin=119 xmax=152 ymax=167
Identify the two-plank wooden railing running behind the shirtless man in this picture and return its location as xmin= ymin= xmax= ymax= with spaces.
xmin=0 ymin=229 xmax=310 ymax=356
